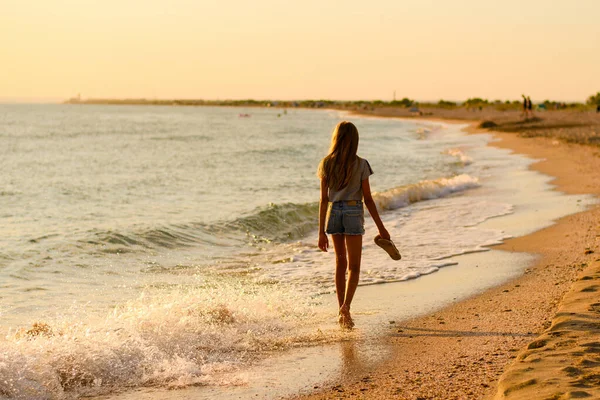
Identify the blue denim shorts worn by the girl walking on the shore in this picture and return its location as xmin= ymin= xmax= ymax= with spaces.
xmin=325 ymin=200 xmax=365 ymax=235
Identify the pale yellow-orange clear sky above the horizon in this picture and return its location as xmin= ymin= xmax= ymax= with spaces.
xmin=0 ymin=0 xmax=600 ymax=101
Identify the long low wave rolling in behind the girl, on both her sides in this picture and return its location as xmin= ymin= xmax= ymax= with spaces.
xmin=82 ymin=175 xmax=479 ymax=253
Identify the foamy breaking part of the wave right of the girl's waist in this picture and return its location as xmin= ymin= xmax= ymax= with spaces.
xmin=373 ymin=174 xmax=479 ymax=210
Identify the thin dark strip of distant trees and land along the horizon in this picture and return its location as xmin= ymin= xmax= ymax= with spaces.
xmin=65 ymin=92 xmax=600 ymax=110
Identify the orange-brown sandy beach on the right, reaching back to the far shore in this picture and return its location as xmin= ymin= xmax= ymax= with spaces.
xmin=294 ymin=110 xmax=600 ymax=399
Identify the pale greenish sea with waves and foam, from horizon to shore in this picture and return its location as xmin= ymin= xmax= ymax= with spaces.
xmin=0 ymin=104 xmax=592 ymax=399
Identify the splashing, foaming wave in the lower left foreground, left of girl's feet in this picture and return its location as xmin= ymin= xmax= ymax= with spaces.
xmin=0 ymin=282 xmax=341 ymax=399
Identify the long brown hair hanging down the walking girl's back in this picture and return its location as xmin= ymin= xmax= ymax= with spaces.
xmin=317 ymin=121 xmax=358 ymax=190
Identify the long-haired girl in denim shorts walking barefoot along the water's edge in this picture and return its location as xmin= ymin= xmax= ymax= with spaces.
xmin=317 ymin=121 xmax=390 ymax=329
